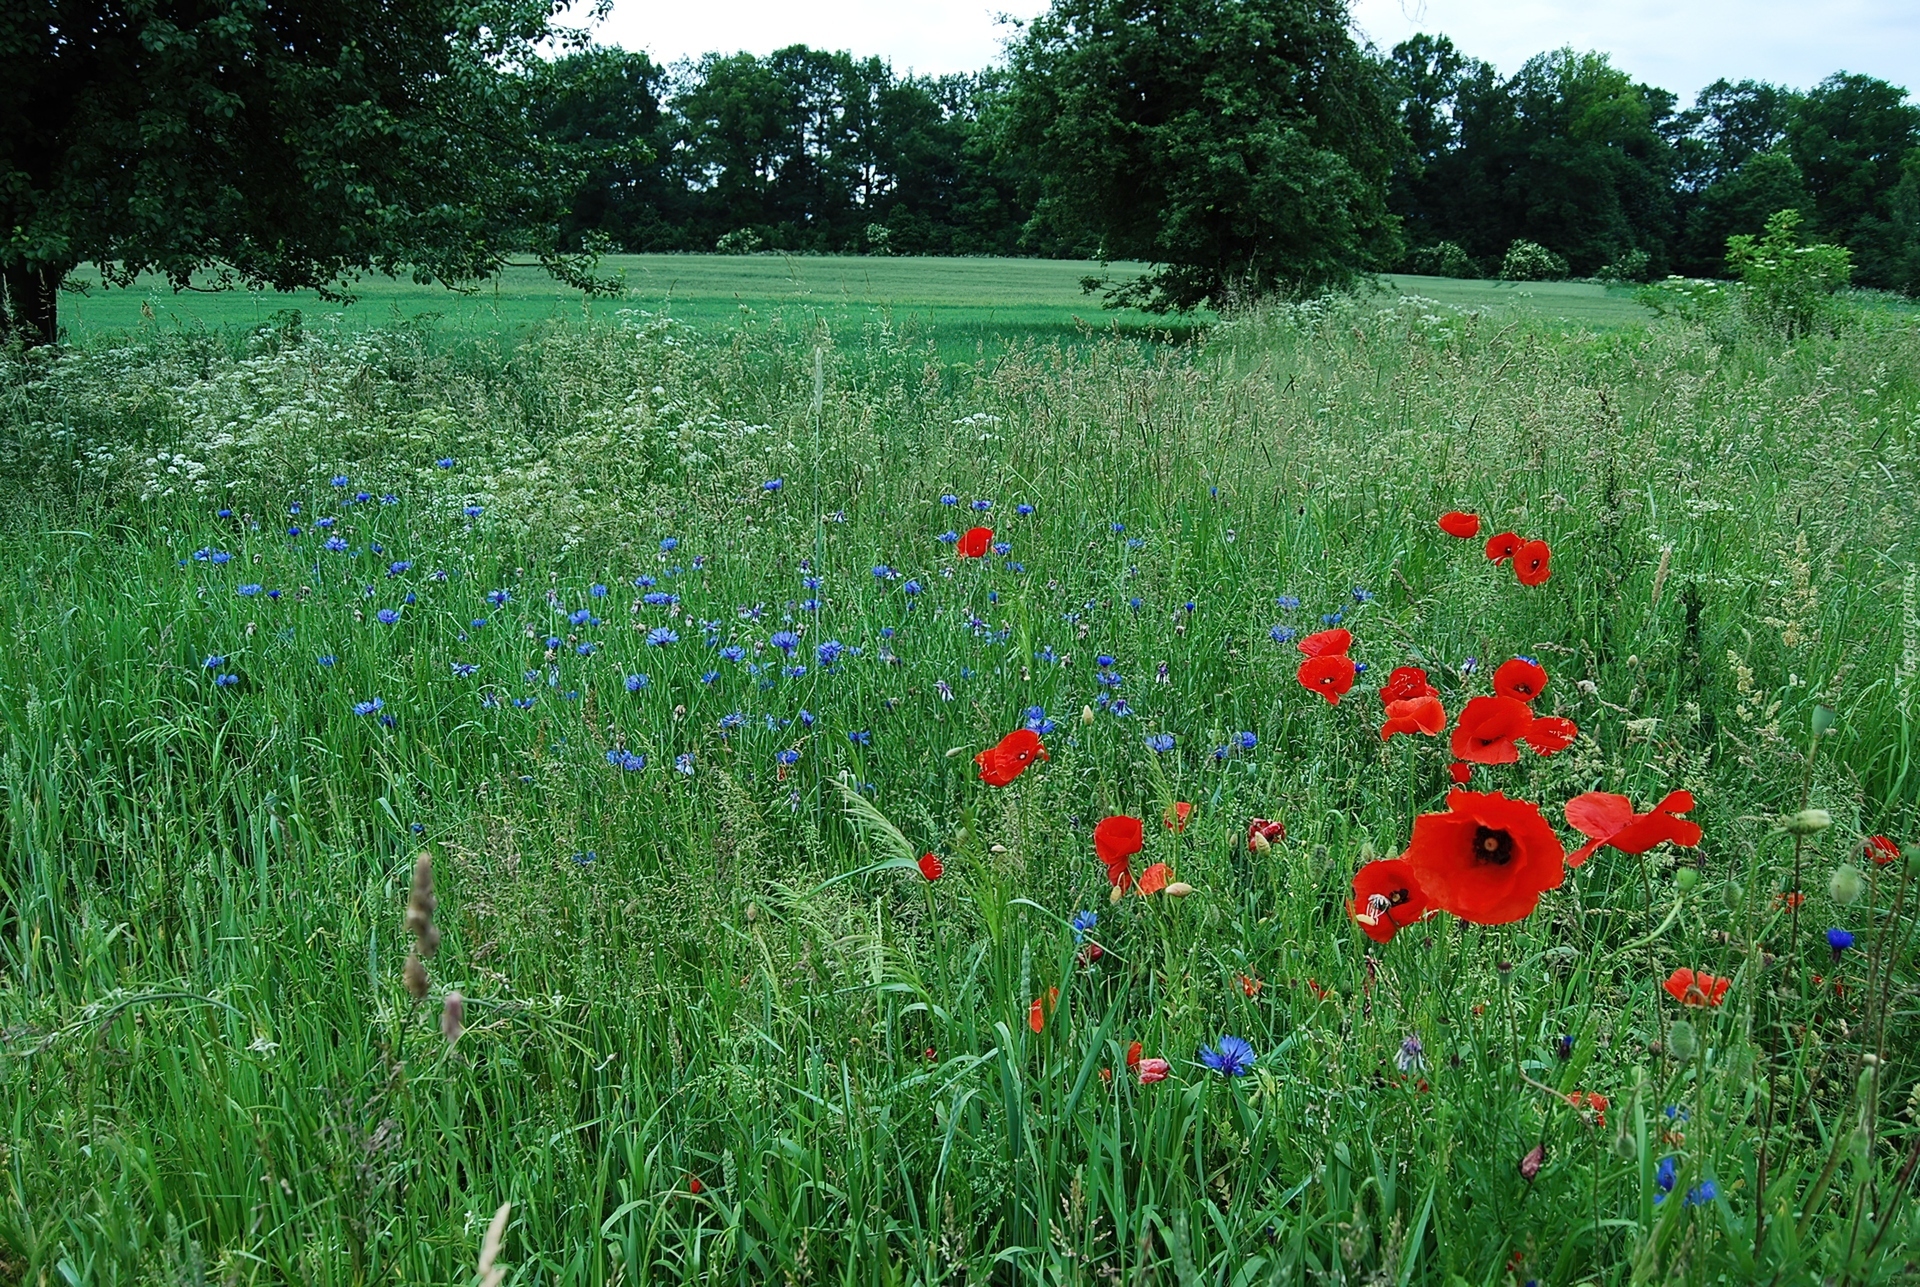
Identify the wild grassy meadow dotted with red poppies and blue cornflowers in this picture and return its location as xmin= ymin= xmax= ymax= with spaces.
xmin=0 ymin=261 xmax=1920 ymax=1287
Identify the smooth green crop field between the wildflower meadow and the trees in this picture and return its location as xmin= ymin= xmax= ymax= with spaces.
xmin=61 ymin=255 xmax=1647 ymax=359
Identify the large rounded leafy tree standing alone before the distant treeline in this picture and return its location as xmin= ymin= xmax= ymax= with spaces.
xmin=1008 ymin=0 xmax=1404 ymax=309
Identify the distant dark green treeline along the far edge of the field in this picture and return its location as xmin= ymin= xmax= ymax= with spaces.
xmin=536 ymin=35 xmax=1920 ymax=292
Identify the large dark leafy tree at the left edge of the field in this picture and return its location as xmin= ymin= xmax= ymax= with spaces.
xmin=0 ymin=0 xmax=587 ymax=344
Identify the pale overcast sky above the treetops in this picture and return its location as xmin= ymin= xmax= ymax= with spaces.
xmin=597 ymin=0 xmax=1920 ymax=102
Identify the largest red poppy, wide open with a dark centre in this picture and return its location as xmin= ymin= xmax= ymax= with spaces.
xmin=1404 ymin=791 xmax=1567 ymax=926
